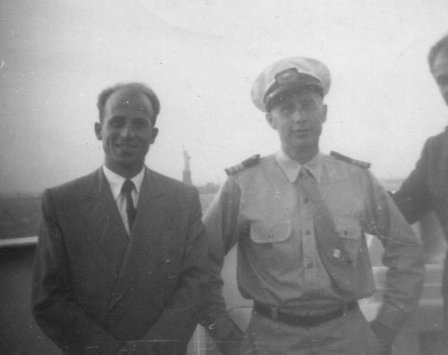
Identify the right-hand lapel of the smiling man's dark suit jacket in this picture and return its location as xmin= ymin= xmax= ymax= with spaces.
xmin=110 ymin=169 xmax=170 ymax=307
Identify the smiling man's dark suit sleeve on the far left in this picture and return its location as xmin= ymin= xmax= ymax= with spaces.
xmin=31 ymin=190 xmax=121 ymax=354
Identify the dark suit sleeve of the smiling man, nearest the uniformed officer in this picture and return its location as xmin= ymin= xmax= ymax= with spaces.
xmin=142 ymin=191 xmax=208 ymax=354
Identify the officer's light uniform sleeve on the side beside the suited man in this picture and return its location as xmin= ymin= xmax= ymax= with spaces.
xmin=201 ymin=176 xmax=243 ymax=354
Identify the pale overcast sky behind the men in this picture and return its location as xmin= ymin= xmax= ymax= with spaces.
xmin=0 ymin=0 xmax=448 ymax=193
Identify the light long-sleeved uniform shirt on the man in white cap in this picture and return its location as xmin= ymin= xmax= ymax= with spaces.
xmin=204 ymin=153 xmax=424 ymax=329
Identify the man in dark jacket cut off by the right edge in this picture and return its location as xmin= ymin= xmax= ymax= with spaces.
xmin=394 ymin=34 xmax=448 ymax=345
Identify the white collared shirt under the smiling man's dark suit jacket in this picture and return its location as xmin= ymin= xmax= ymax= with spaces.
xmin=103 ymin=165 xmax=145 ymax=235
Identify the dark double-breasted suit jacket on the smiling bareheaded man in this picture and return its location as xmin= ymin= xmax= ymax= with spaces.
xmin=32 ymin=169 xmax=207 ymax=354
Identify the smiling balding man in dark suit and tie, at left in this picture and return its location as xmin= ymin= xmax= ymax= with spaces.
xmin=32 ymin=83 xmax=207 ymax=355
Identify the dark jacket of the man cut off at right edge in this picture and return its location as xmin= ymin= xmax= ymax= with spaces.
xmin=393 ymin=129 xmax=448 ymax=304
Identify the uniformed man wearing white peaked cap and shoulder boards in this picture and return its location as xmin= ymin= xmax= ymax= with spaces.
xmin=203 ymin=57 xmax=424 ymax=355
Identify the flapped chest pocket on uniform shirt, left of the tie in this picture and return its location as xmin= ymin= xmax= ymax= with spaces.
xmin=250 ymin=220 xmax=292 ymax=244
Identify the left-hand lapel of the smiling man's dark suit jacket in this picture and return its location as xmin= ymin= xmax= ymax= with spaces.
xmin=80 ymin=169 xmax=128 ymax=282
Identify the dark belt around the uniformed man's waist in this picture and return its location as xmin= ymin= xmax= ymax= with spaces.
xmin=254 ymin=301 xmax=358 ymax=327
